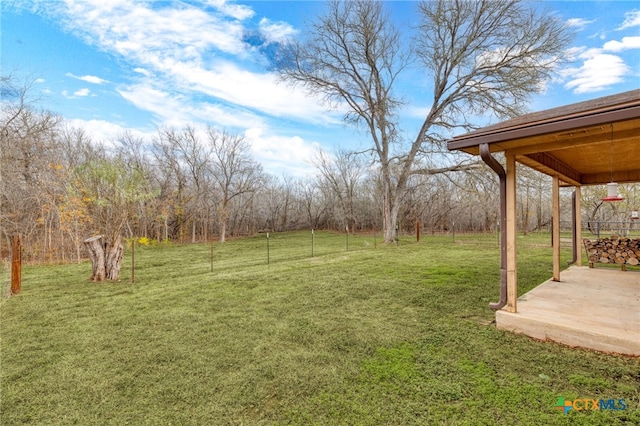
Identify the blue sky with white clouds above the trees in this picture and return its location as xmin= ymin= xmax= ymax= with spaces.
xmin=0 ymin=0 xmax=640 ymax=176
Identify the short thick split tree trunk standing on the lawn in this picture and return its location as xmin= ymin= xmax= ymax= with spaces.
xmin=84 ymin=235 xmax=124 ymax=282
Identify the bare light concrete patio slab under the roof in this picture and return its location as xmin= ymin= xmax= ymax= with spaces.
xmin=496 ymin=266 xmax=640 ymax=355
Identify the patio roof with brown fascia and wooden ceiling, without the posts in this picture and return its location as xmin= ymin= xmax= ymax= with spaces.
xmin=448 ymin=89 xmax=640 ymax=186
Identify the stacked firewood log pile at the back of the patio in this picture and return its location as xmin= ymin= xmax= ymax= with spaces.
xmin=583 ymin=236 xmax=640 ymax=271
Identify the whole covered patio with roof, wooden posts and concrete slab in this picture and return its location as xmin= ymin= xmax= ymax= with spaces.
xmin=448 ymin=90 xmax=640 ymax=355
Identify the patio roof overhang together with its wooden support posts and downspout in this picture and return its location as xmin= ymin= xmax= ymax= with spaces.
xmin=448 ymin=90 xmax=640 ymax=324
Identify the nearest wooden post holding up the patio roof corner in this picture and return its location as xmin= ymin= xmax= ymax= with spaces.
xmin=506 ymin=155 xmax=518 ymax=312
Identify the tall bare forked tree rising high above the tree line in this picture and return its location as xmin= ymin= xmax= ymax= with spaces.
xmin=276 ymin=0 xmax=570 ymax=242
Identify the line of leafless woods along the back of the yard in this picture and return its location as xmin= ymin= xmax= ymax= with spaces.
xmin=0 ymin=74 xmax=640 ymax=261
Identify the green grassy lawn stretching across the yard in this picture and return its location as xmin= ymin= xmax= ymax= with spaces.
xmin=0 ymin=232 xmax=640 ymax=425
